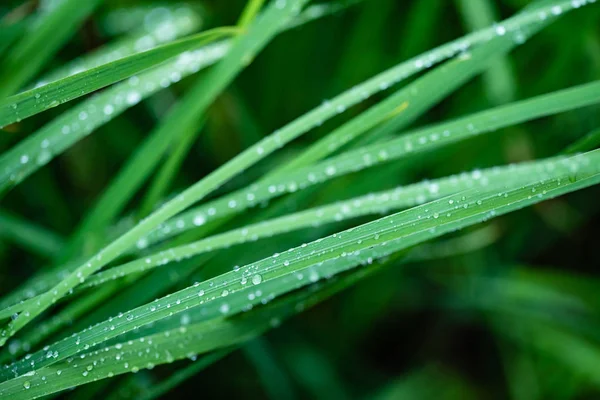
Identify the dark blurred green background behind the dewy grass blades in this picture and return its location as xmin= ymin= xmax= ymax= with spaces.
xmin=0 ymin=0 xmax=600 ymax=400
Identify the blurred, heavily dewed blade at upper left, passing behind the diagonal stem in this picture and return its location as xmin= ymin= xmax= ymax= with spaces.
xmin=0 ymin=0 xmax=360 ymax=200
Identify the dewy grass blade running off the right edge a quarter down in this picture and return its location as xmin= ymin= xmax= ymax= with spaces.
xmin=143 ymin=81 xmax=600 ymax=244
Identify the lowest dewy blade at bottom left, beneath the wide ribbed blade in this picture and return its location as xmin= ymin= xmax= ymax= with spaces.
xmin=0 ymin=267 xmax=376 ymax=399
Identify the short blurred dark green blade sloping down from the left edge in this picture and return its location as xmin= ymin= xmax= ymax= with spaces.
xmin=0 ymin=210 xmax=64 ymax=258
